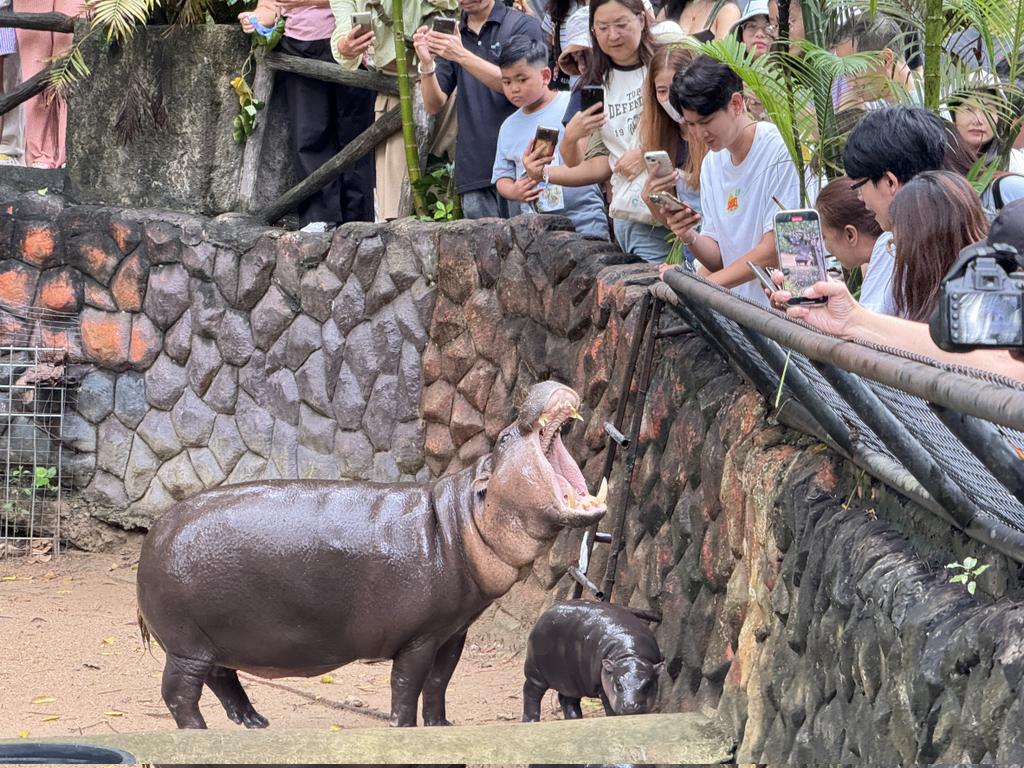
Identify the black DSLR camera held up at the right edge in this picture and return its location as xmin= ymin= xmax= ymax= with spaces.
xmin=929 ymin=243 xmax=1024 ymax=352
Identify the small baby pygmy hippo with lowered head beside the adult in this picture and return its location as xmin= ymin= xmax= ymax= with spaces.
xmin=522 ymin=600 xmax=665 ymax=723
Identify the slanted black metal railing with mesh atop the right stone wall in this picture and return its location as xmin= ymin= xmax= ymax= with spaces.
xmin=665 ymin=270 xmax=1024 ymax=563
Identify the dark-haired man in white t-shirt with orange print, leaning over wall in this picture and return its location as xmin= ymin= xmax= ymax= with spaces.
xmin=651 ymin=56 xmax=810 ymax=304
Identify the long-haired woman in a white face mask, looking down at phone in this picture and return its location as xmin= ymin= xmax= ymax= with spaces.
xmin=639 ymin=45 xmax=708 ymax=261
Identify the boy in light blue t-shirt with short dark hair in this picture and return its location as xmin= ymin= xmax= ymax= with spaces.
xmin=490 ymin=35 xmax=608 ymax=240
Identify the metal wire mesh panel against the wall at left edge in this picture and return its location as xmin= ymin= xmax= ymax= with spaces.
xmin=0 ymin=306 xmax=78 ymax=560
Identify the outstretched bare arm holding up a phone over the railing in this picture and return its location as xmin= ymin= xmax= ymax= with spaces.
xmin=771 ymin=281 xmax=1024 ymax=381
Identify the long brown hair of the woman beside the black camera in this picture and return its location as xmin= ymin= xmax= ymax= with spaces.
xmin=889 ymin=171 xmax=988 ymax=323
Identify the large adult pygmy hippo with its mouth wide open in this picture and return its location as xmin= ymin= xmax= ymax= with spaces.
xmin=132 ymin=382 xmax=607 ymax=728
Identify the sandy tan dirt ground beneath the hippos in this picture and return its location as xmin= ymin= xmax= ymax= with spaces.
xmin=0 ymin=541 xmax=581 ymax=738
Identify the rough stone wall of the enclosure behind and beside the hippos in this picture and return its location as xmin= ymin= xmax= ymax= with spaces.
xmin=0 ymin=189 xmax=1024 ymax=763
